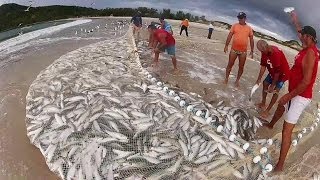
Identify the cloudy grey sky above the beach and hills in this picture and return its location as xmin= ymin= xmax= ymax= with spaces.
xmin=0 ymin=0 xmax=320 ymax=40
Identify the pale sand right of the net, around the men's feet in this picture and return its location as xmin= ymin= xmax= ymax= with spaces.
xmin=136 ymin=19 xmax=320 ymax=179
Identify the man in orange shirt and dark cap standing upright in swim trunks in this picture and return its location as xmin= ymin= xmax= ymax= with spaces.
xmin=224 ymin=12 xmax=254 ymax=87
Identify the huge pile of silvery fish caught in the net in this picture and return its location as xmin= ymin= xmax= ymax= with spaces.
xmin=26 ymin=29 xmax=264 ymax=180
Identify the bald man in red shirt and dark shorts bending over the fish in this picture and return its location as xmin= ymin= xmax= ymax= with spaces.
xmin=256 ymin=40 xmax=290 ymax=119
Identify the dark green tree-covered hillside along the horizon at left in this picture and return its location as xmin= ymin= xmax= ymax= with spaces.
xmin=0 ymin=4 xmax=206 ymax=31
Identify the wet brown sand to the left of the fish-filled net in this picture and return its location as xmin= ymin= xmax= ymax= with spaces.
xmin=0 ymin=16 xmax=129 ymax=180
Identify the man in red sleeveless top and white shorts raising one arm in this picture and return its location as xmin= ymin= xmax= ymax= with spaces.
xmin=266 ymin=12 xmax=319 ymax=171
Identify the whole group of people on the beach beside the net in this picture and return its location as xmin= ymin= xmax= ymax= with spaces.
xmin=134 ymin=12 xmax=319 ymax=171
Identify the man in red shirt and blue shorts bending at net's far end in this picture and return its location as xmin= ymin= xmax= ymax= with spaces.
xmin=148 ymin=25 xmax=178 ymax=72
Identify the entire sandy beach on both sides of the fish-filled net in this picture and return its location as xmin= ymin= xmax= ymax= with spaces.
xmin=0 ymin=18 xmax=320 ymax=180
